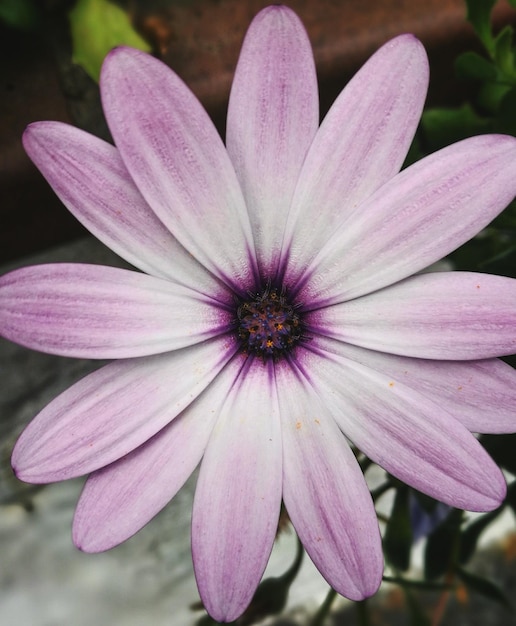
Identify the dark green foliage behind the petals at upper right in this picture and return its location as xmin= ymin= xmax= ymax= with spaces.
xmin=408 ymin=0 xmax=516 ymax=277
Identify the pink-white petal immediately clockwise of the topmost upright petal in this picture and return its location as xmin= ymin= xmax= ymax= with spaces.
xmin=284 ymin=35 xmax=428 ymax=282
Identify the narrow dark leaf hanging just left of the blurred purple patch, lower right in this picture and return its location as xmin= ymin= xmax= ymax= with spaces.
xmin=383 ymin=487 xmax=412 ymax=572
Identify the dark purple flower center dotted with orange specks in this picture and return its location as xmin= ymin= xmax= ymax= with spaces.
xmin=236 ymin=287 xmax=303 ymax=360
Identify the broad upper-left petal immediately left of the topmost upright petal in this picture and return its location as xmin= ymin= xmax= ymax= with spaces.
xmin=100 ymin=48 xmax=256 ymax=291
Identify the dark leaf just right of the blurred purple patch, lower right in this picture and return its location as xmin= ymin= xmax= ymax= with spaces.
xmin=425 ymin=509 xmax=463 ymax=580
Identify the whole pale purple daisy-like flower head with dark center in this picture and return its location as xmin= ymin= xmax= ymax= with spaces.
xmin=0 ymin=6 xmax=516 ymax=621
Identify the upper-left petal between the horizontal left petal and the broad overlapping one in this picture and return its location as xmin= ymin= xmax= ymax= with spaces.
xmin=23 ymin=122 xmax=222 ymax=293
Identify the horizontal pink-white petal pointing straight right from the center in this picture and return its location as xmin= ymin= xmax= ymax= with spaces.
xmin=309 ymin=272 xmax=516 ymax=360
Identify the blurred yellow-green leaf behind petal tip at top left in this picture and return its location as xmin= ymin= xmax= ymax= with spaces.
xmin=69 ymin=0 xmax=150 ymax=82
